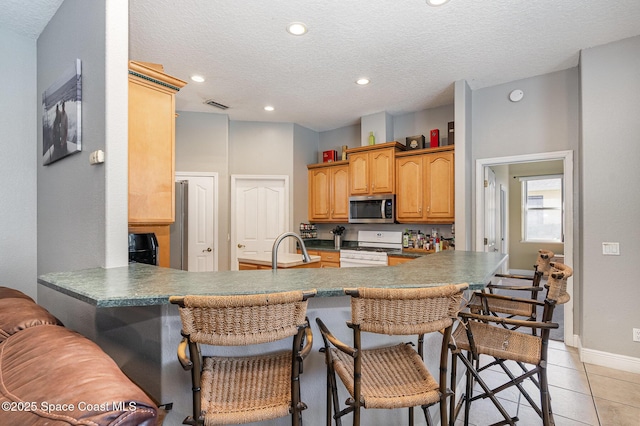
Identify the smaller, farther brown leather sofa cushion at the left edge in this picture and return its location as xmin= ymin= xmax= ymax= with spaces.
xmin=0 ymin=298 xmax=62 ymax=343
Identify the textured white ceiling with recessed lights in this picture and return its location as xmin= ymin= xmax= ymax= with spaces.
xmin=5 ymin=0 xmax=640 ymax=131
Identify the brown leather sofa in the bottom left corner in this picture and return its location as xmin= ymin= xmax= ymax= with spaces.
xmin=0 ymin=287 xmax=158 ymax=426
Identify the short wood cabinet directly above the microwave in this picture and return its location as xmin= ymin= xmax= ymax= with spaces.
xmin=347 ymin=142 xmax=404 ymax=195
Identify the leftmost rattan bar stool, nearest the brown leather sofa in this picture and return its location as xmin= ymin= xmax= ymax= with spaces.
xmin=169 ymin=290 xmax=316 ymax=426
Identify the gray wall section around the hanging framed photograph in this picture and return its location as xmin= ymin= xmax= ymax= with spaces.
xmin=34 ymin=0 xmax=107 ymax=274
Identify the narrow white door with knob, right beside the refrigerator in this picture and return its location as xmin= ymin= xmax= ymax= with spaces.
xmin=176 ymin=173 xmax=218 ymax=272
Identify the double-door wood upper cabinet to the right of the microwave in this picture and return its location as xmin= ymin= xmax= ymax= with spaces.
xmin=396 ymin=147 xmax=455 ymax=223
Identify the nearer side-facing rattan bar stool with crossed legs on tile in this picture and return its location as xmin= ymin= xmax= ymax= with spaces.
xmin=450 ymin=263 xmax=573 ymax=426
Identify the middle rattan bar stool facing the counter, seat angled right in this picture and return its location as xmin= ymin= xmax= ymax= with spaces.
xmin=316 ymin=284 xmax=468 ymax=426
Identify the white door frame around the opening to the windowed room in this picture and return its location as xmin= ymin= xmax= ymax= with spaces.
xmin=475 ymin=150 xmax=578 ymax=347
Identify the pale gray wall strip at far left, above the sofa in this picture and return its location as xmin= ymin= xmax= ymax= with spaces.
xmin=0 ymin=28 xmax=37 ymax=298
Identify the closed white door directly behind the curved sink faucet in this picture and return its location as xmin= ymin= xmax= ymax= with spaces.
xmin=230 ymin=175 xmax=289 ymax=271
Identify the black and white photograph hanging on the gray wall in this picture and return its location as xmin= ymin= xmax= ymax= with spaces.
xmin=42 ymin=59 xmax=82 ymax=166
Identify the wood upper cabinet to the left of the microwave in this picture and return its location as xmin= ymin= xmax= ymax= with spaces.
xmin=307 ymin=161 xmax=349 ymax=223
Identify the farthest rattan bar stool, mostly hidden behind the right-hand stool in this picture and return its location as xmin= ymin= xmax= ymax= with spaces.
xmin=467 ymin=249 xmax=554 ymax=334
